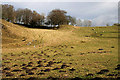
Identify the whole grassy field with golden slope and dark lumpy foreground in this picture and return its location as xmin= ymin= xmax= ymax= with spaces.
xmin=2 ymin=20 xmax=119 ymax=79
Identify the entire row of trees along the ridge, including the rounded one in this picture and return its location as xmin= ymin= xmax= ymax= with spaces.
xmin=2 ymin=4 xmax=91 ymax=27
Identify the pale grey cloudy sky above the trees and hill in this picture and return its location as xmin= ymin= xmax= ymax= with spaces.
xmin=3 ymin=2 xmax=118 ymax=26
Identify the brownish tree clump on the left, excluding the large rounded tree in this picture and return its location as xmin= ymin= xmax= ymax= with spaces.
xmin=2 ymin=4 xmax=45 ymax=27
